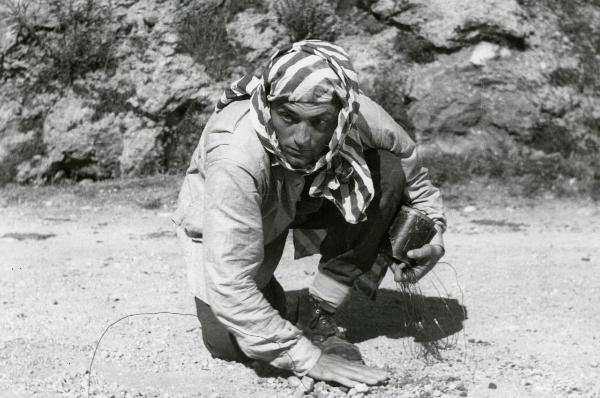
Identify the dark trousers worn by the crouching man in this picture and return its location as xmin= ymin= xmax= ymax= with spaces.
xmin=196 ymin=150 xmax=405 ymax=362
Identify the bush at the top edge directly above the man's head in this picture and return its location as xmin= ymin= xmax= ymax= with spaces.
xmin=273 ymin=0 xmax=338 ymax=41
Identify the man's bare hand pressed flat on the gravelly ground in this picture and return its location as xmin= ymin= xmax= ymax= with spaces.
xmin=307 ymin=354 xmax=388 ymax=388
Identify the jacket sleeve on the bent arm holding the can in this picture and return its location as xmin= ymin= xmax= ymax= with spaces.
xmin=357 ymin=95 xmax=446 ymax=235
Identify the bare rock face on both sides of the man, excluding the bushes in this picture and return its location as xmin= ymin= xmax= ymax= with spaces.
xmin=0 ymin=0 xmax=600 ymax=182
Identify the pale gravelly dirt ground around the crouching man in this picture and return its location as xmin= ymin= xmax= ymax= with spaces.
xmin=0 ymin=177 xmax=600 ymax=398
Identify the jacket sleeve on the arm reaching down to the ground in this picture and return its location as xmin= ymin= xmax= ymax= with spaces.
xmin=204 ymin=149 xmax=321 ymax=375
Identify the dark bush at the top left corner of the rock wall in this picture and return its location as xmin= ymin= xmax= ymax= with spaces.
xmin=10 ymin=0 xmax=116 ymax=85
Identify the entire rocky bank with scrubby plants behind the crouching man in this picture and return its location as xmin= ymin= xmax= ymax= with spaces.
xmin=0 ymin=0 xmax=600 ymax=197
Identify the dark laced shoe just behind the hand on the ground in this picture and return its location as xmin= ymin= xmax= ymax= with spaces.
xmin=298 ymin=295 xmax=363 ymax=362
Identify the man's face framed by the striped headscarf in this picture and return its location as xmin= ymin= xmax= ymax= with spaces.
xmin=271 ymin=101 xmax=340 ymax=168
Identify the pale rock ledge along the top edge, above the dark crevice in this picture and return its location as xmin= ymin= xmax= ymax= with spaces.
xmin=371 ymin=0 xmax=532 ymax=49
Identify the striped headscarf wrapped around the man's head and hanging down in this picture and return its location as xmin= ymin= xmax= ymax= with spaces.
xmin=216 ymin=40 xmax=375 ymax=224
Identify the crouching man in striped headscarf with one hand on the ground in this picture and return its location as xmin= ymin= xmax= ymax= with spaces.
xmin=175 ymin=40 xmax=445 ymax=387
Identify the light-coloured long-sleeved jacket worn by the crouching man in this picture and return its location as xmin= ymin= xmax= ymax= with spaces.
xmin=173 ymin=95 xmax=446 ymax=375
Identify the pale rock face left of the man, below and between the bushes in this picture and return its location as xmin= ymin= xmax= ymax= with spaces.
xmin=0 ymin=0 xmax=219 ymax=182
